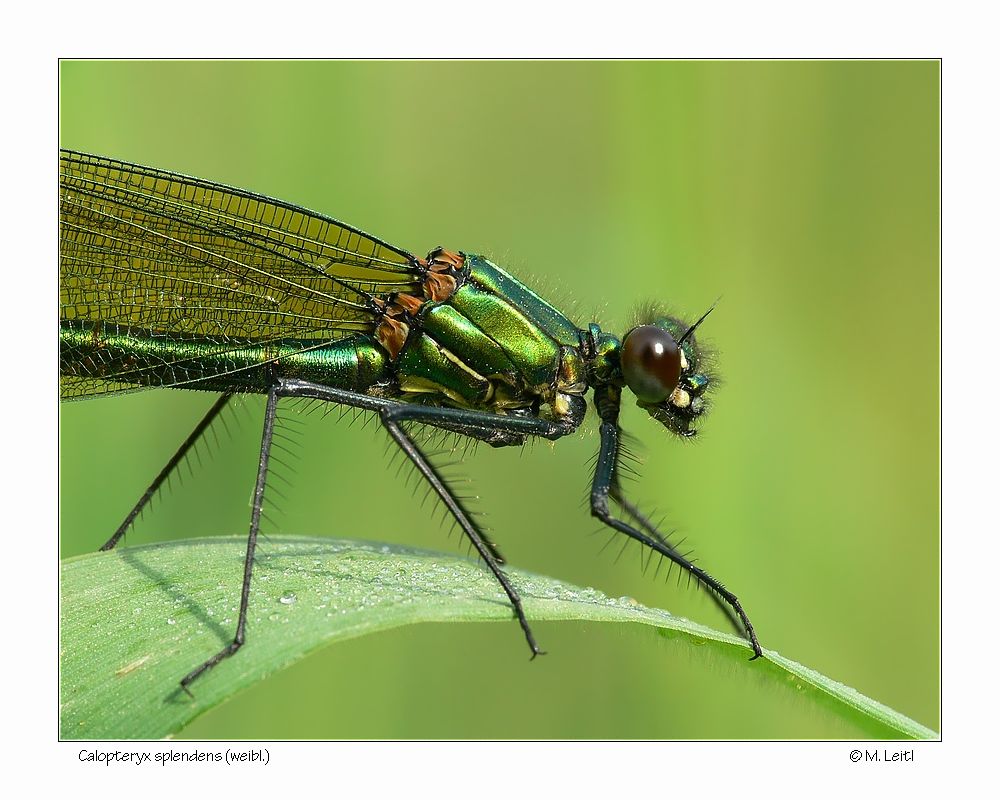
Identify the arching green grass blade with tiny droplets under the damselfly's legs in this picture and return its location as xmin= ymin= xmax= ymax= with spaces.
xmin=60 ymin=536 xmax=937 ymax=739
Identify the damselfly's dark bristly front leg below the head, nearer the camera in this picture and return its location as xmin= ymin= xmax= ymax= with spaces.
xmin=590 ymin=391 xmax=763 ymax=661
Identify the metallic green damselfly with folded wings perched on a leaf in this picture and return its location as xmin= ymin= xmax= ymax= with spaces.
xmin=59 ymin=151 xmax=761 ymax=690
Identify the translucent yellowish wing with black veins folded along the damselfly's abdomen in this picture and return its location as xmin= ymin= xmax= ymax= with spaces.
xmin=59 ymin=150 xmax=419 ymax=397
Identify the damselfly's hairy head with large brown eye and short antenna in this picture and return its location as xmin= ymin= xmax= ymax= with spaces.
xmin=620 ymin=306 xmax=714 ymax=437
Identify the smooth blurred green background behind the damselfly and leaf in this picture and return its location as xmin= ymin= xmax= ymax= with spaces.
xmin=60 ymin=61 xmax=940 ymax=738
